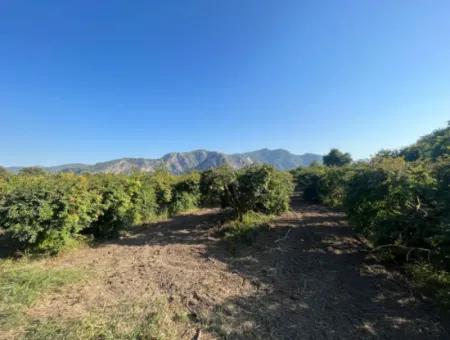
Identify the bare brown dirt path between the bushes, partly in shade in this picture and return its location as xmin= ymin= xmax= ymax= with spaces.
xmin=29 ymin=205 xmax=450 ymax=339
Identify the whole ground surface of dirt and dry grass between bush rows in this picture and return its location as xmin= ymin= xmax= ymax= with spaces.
xmin=0 ymin=206 xmax=450 ymax=340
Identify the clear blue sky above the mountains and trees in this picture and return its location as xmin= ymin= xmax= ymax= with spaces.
xmin=0 ymin=0 xmax=450 ymax=166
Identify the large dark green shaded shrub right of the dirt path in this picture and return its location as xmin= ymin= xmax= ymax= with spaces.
xmin=344 ymin=158 xmax=438 ymax=246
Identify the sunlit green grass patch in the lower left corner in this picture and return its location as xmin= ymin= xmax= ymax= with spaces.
xmin=0 ymin=259 xmax=85 ymax=331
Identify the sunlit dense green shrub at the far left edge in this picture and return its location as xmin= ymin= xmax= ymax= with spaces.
xmin=0 ymin=174 xmax=99 ymax=253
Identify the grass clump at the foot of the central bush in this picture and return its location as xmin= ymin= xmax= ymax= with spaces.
xmin=224 ymin=211 xmax=274 ymax=245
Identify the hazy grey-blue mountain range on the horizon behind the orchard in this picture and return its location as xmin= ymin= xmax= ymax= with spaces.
xmin=7 ymin=149 xmax=322 ymax=174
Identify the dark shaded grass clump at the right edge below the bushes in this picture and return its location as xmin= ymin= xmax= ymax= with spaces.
xmin=406 ymin=263 xmax=450 ymax=310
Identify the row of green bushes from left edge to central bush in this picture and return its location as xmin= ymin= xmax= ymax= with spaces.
xmin=0 ymin=165 xmax=293 ymax=254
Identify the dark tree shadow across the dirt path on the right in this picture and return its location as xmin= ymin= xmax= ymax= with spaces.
xmin=103 ymin=204 xmax=450 ymax=339
